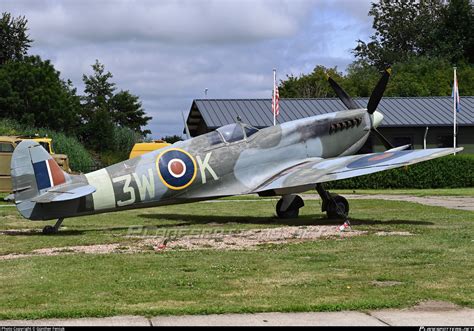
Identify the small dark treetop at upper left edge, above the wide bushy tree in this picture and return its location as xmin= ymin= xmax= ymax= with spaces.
xmin=0 ymin=12 xmax=33 ymax=65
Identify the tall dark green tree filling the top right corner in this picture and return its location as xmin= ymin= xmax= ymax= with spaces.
xmin=353 ymin=0 xmax=474 ymax=70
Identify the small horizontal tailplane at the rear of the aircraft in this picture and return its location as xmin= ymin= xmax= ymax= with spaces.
xmin=31 ymin=183 xmax=96 ymax=203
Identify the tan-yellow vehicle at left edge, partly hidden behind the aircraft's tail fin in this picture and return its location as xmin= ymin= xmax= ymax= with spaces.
xmin=0 ymin=136 xmax=71 ymax=192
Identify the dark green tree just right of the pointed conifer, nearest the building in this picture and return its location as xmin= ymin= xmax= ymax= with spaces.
xmin=110 ymin=91 xmax=151 ymax=137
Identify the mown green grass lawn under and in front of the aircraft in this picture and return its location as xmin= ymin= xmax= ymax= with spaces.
xmin=0 ymin=196 xmax=474 ymax=319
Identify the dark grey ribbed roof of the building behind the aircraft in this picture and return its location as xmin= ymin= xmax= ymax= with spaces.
xmin=188 ymin=96 xmax=474 ymax=129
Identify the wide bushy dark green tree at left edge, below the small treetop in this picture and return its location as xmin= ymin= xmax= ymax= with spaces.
xmin=0 ymin=56 xmax=80 ymax=133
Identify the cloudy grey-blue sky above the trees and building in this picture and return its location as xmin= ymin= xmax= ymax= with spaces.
xmin=0 ymin=0 xmax=372 ymax=138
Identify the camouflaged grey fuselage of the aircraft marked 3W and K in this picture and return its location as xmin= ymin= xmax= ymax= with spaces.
xmin=20 ymin=109 xmax=372 ymax=220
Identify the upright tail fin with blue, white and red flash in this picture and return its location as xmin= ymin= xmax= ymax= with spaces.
xmin=11 ymin=140 xmax=70 ymax=218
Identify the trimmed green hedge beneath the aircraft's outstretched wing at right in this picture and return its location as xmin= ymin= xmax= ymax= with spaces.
xmin=327 ymin=154 xmax=474 ymax=189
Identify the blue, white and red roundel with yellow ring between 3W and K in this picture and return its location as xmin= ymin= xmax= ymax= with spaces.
xmin=156 ymin=148 xmax=197 ymax=190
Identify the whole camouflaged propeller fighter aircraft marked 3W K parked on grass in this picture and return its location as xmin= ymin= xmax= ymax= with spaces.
xmin=11 ymin=70 xmax=462 ymax=233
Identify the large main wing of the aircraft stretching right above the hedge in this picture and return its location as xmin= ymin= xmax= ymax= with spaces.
xmin=252 ymin=148 xmax=463 ymax=193
